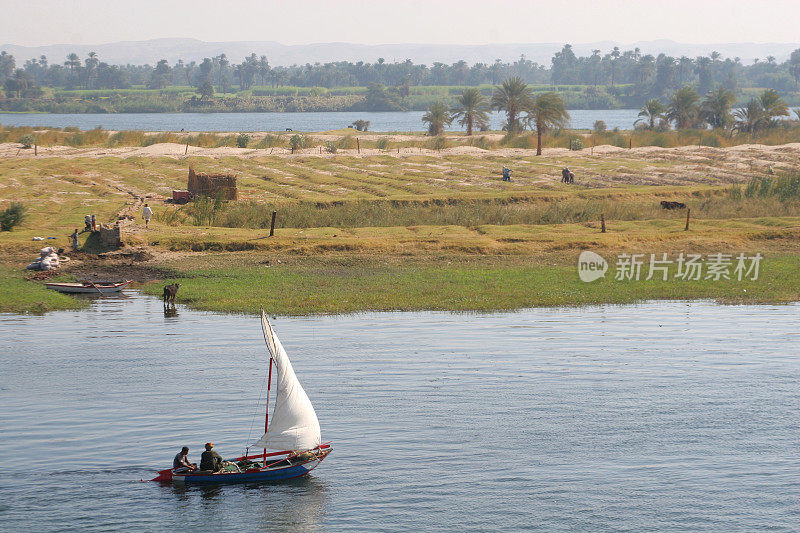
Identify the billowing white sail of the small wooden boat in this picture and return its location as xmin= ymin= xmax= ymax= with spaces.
xmin=251 ymin=311 xmax=322 ymax=451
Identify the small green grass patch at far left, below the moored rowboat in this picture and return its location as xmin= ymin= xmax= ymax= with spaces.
xmin=0 ymin=266 xmax=88 ymax=314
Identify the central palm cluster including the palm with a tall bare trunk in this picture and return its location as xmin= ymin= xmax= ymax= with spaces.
xmin=422 ymin=77 xmax=569 ymax=155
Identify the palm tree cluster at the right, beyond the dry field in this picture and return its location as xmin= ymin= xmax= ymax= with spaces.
xmin=635 ymin=85 xmax=800 ymax=134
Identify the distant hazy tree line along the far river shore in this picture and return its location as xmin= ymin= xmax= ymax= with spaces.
xmin=0 ymin=44 xmax=800 ymax=102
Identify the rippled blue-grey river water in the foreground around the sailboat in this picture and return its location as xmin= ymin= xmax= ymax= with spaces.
xmin=0 ymin=293 xmax=800 ymax=532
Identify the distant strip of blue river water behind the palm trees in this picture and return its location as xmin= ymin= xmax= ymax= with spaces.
xmin=0 ymin=109 xmax=639 ymax=132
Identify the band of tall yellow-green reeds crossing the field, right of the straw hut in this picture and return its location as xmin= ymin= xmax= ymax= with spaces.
xmin=175 ymin=187 xmax=800 ymax=229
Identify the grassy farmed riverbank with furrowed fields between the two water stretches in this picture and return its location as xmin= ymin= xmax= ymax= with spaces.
xmin=0 ymin=145 xmax=800 ymax=315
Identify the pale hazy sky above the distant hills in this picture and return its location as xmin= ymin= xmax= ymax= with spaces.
xmin=0 ymin=0 xmax=800 ymax=46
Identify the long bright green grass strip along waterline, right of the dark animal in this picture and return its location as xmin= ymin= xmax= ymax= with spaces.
xmin=144 ymin=255 xmax=800 ymax=315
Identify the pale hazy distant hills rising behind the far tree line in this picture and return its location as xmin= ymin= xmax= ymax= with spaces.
xmin=0 ymin=39 xmax=800 ymax=66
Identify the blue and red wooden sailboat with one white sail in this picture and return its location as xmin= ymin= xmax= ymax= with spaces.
xmin=152 ymin=308 xmax=333 ymax=483
